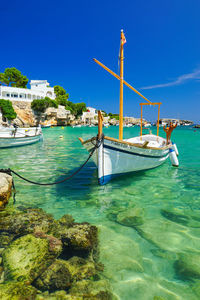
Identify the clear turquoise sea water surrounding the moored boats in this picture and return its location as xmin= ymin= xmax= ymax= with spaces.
xmin=0 ymin=127 xmax=200 ymax=300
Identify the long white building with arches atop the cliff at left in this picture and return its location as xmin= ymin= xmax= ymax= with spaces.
xmin=0 ymin=80 xmax=56 ymax=102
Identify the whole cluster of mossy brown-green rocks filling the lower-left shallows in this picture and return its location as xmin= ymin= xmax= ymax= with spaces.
xmin=0 ymin=207 xmax=115 ymax=300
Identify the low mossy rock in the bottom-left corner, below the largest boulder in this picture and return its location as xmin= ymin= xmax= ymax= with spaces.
xmin=0 ymin=282 xmax=37 ymax=300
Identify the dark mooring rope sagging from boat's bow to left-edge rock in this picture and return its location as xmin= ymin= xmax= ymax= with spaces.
xmin=0 ymin=134 xmax=104 ymax=203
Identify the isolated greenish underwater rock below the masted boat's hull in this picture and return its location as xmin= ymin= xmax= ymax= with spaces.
xmin=117 ymin=207 xmax=144 ymax=227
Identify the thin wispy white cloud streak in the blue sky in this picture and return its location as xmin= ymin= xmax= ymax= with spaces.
xmin=141 ymin=69 xmax=200 ymax=90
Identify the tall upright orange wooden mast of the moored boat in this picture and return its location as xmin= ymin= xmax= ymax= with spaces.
xmin=119 ymin=30 xmax=126 ymax=140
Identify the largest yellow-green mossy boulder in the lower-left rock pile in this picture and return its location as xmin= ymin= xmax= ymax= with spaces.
xmin=2 ymin=234 xmax=62 ymax=282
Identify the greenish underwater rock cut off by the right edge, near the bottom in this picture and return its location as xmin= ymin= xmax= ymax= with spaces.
xmin=174 ymin=253 xmax=200 ymax=279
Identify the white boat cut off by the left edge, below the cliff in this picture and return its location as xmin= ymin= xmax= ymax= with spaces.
xmin=0 ymin=127 xmax=42 ymax=148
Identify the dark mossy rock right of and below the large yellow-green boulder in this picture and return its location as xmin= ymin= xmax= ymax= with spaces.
xmin=34 ymin=259 xmax=71 ymax=291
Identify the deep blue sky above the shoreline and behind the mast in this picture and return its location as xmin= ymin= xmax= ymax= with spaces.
xmin=0 ymin=0 xmax=200 ymax=122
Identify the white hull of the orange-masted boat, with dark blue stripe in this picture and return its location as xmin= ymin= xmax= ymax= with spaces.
xmin=84 ymin=135 xmax=169 ymax=185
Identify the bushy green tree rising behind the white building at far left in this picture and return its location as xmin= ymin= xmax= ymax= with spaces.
xmin=0 ymin=68 xmax=28 ymax=88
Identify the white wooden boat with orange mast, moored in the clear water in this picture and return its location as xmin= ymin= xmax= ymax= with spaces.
xmin=79 ymin=31 xmax=179 ymax=185
